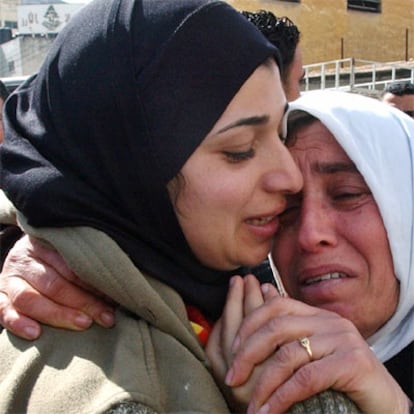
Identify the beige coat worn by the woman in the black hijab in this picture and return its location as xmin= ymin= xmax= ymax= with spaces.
xmin=0 ymin=215 xmax=228 ymax=414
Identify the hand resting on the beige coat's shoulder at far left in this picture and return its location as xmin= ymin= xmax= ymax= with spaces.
xmin=0 ymin=235 xmax=114 ymax=339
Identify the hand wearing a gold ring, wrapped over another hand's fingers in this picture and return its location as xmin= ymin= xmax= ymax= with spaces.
xmin=222 ymin=297 xmax=408 ymax=414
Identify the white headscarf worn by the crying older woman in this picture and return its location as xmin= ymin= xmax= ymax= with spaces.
xmin=285 ymin=91 xmax=414 ymax=361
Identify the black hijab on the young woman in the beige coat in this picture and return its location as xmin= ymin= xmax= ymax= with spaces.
xmin=0 ymin=0 xmax=277 ymax=318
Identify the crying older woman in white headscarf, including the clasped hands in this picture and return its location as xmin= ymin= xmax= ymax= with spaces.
xmin=207 ymin=91 xmax=414 ymax=414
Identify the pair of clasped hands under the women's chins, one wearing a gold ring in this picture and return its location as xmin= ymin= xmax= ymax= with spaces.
xmin=207 ymin=275 xmax=410 ymax=414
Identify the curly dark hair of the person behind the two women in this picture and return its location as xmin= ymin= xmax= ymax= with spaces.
xmin=241 ymin=10 xmax=300 ymax=72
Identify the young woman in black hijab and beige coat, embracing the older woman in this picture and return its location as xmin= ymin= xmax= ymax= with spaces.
xmin=0 ymin=0 xmax=301 ymax=413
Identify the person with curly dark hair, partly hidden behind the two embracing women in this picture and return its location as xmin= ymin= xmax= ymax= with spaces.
xmin=242 ymin=10 xmax=304 ymax=101
